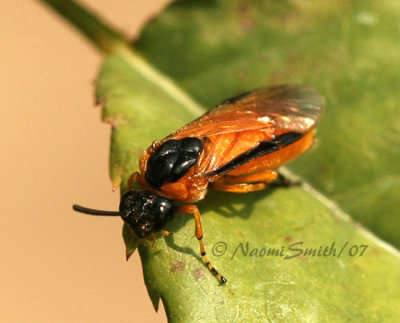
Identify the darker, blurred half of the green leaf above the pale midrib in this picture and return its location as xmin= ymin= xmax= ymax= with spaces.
xmin=136 ymin=0 xmax=400 ymax=246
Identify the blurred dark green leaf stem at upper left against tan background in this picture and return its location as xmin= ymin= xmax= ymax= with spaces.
xmin=39 ymin=0 xmax=127 ymax=54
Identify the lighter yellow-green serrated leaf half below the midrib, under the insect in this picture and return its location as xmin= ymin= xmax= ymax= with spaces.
xmin=97 ymin=55 xmax=400 ymax=322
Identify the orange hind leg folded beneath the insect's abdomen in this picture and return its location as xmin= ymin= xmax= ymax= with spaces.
xmin=212 ymin=169 xmax=278 ymax=193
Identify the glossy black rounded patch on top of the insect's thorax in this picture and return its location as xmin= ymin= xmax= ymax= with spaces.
xmin=145 ymin=138 xmax=203 ymax=188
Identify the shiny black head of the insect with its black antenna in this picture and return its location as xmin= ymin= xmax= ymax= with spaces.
xmin=73 ymin=191 xmax=175 ymax=239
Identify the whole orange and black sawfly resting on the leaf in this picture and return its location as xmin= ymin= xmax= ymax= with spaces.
xmin=73 ymin=85 xmax=324 ymax=283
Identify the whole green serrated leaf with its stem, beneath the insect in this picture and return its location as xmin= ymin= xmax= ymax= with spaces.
xmin=39 ymin=0 xmax=400 ymax=322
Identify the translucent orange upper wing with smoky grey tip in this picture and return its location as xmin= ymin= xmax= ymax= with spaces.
xmin=169 ymin=85 xmax=325 ymax=138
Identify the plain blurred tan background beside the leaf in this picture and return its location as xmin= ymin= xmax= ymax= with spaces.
xmin=0 ymin=0 xmax=167 ymax=322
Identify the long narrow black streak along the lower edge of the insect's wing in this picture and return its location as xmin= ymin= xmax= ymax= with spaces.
xmin=205 ymin=132 xmax=303 ymax=177
